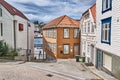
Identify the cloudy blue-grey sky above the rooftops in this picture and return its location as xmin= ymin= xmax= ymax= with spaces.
xmin=5 ymin=0 xmax=96 ymax=22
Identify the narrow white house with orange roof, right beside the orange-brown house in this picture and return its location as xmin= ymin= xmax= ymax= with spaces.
xmin=80 ymin=4 xmax=96 ymax=64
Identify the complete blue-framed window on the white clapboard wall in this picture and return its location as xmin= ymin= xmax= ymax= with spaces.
xmin=101 ymin=17 xmax=111 ymax=44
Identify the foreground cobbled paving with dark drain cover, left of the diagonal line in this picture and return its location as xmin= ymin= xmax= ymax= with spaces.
xmin=0 ymin=64 xmax=68 ymax=80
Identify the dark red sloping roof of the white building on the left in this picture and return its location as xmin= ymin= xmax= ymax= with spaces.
xmin=0 ymin=0 xmax=28 ymax=20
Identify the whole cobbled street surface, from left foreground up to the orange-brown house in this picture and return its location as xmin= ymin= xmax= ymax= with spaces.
xmin=0 ymin=59 xmax=101 ymax=80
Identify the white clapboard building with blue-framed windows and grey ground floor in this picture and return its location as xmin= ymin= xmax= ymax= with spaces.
xmin=96 ymin=0 xmax=120 ymax=79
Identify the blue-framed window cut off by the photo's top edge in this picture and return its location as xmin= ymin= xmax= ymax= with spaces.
xmin=102 ymin=0 xmax=112 ymax=13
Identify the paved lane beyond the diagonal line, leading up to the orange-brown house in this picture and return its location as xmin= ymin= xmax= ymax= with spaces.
xmin=25 ymin=59 xmax=101 ymax=80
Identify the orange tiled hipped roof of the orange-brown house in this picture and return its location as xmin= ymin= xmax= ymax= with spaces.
xmin=43 ymin=15 xmax=80 ymax=29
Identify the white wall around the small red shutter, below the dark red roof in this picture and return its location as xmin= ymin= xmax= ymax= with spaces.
xmin=0 ymin=5 xmax=34 ymax=54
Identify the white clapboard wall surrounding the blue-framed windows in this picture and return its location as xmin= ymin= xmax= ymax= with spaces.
xmin=96 ymin=0 xmax=120 ymax=56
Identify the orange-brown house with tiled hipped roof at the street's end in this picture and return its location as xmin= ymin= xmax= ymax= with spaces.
xmin=43 ymin=15 xmax=80 ymax=59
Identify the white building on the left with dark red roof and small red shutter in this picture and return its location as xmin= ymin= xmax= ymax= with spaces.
xmin=0 ymin=0 xmax=34 ymax=55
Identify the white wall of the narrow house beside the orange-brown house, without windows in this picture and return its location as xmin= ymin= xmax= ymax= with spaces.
xmin=80 ymin=9 xmax=96 ymax=64
